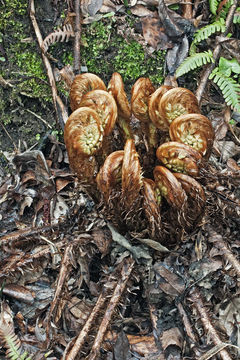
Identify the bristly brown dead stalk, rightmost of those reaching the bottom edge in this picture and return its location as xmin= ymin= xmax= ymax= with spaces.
xmin=190 ymin=289 xmax=232 ymax=360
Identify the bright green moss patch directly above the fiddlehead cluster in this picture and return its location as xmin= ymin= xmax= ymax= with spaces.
xmin=62 ymin=17 xmax=165 ymax=85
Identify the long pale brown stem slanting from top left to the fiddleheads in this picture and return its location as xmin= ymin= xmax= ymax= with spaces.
xmin=30 ymin=0 xmax=68 ymax=129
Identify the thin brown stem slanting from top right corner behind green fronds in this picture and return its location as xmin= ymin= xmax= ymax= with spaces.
xmin=196 ymin=0 xmax=238 ymax=103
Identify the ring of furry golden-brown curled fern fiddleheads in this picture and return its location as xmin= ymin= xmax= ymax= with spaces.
xmin=64 ymin=73 xmax=214 ymax=248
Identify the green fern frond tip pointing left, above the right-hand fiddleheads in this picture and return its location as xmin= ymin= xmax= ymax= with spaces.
xmin=175 ymin=50 xmax=214 ymax=78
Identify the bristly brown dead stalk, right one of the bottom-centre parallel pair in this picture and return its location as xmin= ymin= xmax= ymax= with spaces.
xmin=88 ymin=258 xmax=135 ymax=360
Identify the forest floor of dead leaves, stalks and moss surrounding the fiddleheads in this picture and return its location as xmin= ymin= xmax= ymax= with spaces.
xmin=0 ymin=0 xmax=240 ymax=360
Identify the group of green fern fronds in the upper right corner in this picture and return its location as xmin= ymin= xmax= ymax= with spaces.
xmin=176 ymin=0 xmax=240 ymax=112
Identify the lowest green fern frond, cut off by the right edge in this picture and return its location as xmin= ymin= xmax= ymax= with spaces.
xmin=209 ymin=68 xmax=240 ymax=112
